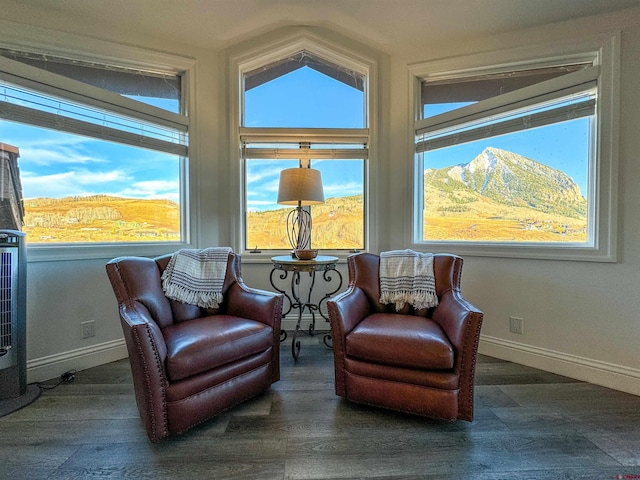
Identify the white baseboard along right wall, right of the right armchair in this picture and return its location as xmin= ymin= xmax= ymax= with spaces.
xmin=478 ymin=335 xmax=640 ymax=395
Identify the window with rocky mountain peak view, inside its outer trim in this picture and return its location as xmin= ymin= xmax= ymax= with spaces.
xmin=414 ymin=36 xmax=611 ymax=262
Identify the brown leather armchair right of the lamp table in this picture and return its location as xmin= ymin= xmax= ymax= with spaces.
xmin=327 ymin=253 xmax=483 ymax=421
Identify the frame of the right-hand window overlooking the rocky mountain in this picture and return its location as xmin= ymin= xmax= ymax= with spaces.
xmin=406 ymin=34 xmax=620 ymax=262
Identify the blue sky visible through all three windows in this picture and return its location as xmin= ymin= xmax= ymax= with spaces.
xmin=0 ymin=63 xmax=588 ymax=206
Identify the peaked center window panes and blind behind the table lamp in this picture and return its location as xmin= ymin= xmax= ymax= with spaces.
xmin=240 ymin=50 xmax=368 ymax=250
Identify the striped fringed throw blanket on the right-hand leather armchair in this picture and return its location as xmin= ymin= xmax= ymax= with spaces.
xmin=380 ymin=250 xmax=438 ymax=310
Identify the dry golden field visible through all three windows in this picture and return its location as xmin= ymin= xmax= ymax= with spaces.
xmin=23 ymin=190 xmax=586 ymax=246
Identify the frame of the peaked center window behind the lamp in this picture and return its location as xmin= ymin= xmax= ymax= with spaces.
xmin=229 ymin=28 xmax=377 ymax=263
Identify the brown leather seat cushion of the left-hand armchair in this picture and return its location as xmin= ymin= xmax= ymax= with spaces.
xmin=162 ymin=315 xmax=273 ymax=382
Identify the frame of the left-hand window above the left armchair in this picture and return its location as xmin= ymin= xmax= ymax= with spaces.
xmin=0 ymin=22 xmax=195 ymax=262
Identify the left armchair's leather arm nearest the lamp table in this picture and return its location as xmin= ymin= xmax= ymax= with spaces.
xmin=224 ymin=282 xmax=284 ymax=331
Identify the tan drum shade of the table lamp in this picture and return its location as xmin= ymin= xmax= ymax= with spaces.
xmin=278 ymin=168 xmax=324 ymax=206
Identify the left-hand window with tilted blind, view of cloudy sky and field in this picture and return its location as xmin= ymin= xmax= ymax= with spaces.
xmin=0 ymin=51 xmax=188 ymax=244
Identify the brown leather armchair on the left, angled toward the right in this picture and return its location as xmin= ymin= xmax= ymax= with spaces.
xmin=106 ymin=253 xmax=282 ymax=442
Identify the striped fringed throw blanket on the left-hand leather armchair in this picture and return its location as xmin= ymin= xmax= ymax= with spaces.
xmin=162 ymin=247 xmax=231 ymax=308
